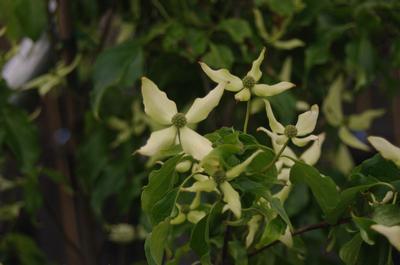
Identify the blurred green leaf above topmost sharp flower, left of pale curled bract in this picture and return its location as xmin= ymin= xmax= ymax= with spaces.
xmin=218 ymin=18 xmax=252 ymax=43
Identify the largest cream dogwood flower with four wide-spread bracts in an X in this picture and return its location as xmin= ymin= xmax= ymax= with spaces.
xmin=137 ymin=77 xmax=225 ymax=160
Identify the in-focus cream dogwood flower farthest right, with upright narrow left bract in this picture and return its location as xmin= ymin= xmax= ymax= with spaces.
xmin=257 ymin=100 xmax=319 ymax=147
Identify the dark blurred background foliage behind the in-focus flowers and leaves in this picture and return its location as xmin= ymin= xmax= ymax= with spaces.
xmin=0 ymin=0 xmax=400 ymax=265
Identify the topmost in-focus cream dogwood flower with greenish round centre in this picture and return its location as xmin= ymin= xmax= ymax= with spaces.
xmin=200 ymin=48 xmax=295 ymax=101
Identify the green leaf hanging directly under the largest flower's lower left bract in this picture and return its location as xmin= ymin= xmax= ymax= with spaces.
xmin=142 ymin=156 xmax=181 ymax=217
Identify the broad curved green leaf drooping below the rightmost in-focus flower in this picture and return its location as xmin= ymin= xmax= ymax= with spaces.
xmin=290 ymin=162 xmax=339 ymax=218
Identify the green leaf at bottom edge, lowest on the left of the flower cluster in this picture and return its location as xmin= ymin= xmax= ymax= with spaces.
xmin=145 ymin=219 xmax=171 ymax=265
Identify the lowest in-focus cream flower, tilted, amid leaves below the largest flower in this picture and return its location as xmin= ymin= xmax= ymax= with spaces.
xmin=182 ymin=150 xmax=263 ymax=219
